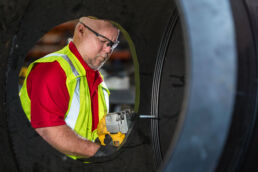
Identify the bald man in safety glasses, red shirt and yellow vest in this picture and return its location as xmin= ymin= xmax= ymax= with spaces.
xmin=20 ymin=17 xmax=119 ymax=159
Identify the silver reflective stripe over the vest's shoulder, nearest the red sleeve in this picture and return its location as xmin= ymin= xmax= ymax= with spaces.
xmin=45 ymin=53 xmax=80 ymax=129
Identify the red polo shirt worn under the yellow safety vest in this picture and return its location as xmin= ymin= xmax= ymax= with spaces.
xmin=27 ymin=42 xmax=102 ymax=130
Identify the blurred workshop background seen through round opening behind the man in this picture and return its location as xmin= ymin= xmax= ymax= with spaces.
xmin=19 ymin=20 xmax=135 ymax=112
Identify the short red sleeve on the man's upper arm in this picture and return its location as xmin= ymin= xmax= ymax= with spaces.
xmin=27 ymin=62 xmax=69 ymax=128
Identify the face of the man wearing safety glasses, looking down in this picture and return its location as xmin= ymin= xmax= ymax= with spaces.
xmin=79 ymin=23 xmax=119 ymax=70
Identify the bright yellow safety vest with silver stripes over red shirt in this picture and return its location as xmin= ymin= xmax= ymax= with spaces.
xmin=19 ymin=45 xmax=110 ymax=159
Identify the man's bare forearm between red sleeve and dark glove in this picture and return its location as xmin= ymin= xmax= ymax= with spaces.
xmin=36 ymin=125 xmax=100 ymax=157
